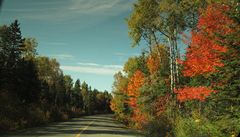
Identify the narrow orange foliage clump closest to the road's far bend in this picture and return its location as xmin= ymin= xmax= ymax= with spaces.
xmin=127 ymin=70 xmax=144 ymax=108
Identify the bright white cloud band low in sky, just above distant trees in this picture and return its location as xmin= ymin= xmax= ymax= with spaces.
xmin=61 ymin=62 xmax=123 ymax=75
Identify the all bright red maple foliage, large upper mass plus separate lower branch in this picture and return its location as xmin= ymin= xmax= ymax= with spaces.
xmin=174 ymin=3 xmax=234 ymax=102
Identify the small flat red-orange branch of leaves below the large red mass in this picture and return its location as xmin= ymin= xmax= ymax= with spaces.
xmin=174 ymin=86 xmax=216 ymax=102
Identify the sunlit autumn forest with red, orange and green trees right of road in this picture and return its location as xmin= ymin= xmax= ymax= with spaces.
xmin=111 ymin=0 xmax=240 ymax=137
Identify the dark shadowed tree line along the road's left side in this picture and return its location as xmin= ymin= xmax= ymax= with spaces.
xmin=0 ymin=20 xmax=112 ymax=131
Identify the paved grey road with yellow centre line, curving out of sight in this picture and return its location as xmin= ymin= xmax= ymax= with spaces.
xmin=0 ymin=114 xmax=142 ymax=137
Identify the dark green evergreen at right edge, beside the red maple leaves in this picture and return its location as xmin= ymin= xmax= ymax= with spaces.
xmin=208 ymin=0 xmax=240 ymax=136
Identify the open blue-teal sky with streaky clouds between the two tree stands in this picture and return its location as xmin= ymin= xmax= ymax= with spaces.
xmin=0 ymin=0 xmax=143 ymax=91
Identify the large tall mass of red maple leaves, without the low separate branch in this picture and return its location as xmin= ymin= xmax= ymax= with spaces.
xmin=183 ymin=4 xmax=233 ymax=77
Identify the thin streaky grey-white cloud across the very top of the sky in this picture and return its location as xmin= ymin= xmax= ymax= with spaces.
xmin=0 ymin=0 xmax=134 ymax=21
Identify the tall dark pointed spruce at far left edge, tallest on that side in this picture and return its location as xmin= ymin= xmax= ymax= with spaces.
xmin=0 ymin=20 xmax=23 ymax=91
